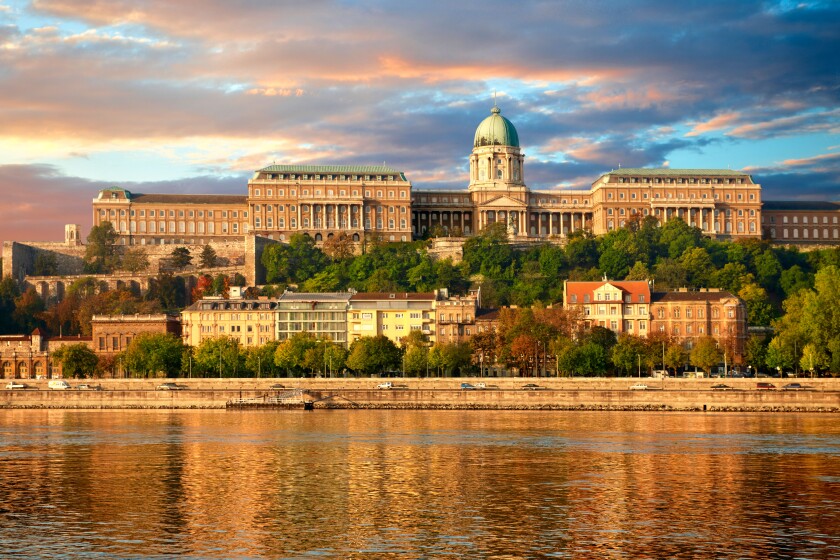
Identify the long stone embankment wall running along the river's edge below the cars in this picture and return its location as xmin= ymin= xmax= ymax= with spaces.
xmin=0 ymin=378 xmax=840 ymax=412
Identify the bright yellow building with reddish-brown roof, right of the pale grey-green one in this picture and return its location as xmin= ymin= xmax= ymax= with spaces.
xmin=347 ymin=292 xmax=438 ymax=344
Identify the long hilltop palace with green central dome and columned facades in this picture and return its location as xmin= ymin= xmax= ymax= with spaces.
xmin=88 ymin=105 xmax=840 ymax=245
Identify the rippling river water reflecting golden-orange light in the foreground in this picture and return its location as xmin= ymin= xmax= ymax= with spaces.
xmin=0 ymin=410 xmax=840 ymax=559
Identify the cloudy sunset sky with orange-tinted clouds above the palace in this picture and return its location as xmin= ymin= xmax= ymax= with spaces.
xmin=0 ymin=0 xmax=840 ymax=241
